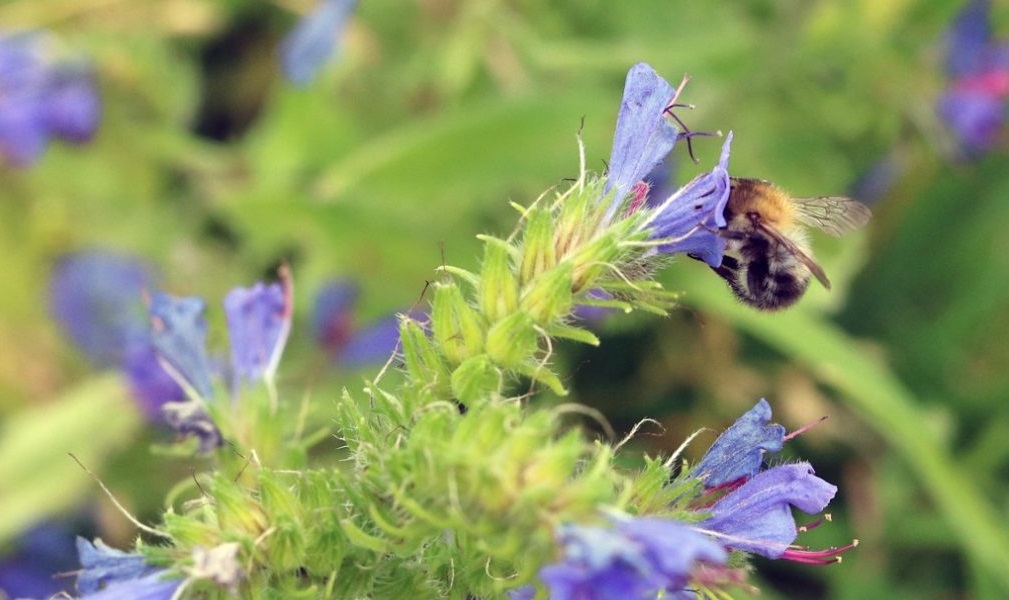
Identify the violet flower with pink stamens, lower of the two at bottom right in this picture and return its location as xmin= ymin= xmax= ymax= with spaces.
xmin=697 ymin=463 xmax=837 ymax=559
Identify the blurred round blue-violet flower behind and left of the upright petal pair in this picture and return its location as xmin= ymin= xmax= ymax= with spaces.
xmin=48 ymin=250 xmax=153 ymax=366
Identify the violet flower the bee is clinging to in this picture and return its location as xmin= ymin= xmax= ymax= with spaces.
xmin=645 ymin=131 xmax=733 ymax=266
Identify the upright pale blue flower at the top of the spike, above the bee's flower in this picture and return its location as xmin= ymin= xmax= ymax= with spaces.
xmin=603 ymin=63 xmax=678 ymax=220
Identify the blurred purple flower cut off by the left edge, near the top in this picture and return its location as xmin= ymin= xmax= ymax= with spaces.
xmin=0 ymin=33 xmax=101 ymax=166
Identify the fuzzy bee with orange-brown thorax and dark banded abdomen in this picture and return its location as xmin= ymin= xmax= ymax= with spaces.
xmin=712 ymin=177 xmax=872 ymax=311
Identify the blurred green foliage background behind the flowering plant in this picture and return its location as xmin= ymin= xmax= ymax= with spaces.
xmin=0 ymin=0 xmax=1009 ymax=598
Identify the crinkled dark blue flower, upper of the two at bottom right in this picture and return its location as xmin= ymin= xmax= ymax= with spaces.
xmin=693 ymin=398 xmax=785 ymax=488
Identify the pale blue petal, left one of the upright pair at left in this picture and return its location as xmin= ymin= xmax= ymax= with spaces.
xmin=148 ymin=291 xmax=213 ymax=398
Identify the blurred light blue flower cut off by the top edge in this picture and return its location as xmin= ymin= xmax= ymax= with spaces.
xmin=281 ymin=0 xmax=357 ymax=86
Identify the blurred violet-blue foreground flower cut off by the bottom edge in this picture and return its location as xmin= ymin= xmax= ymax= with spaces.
xmin=532 ymin=517 xmax=725 ymax=600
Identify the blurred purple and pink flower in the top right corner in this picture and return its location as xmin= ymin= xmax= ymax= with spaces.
xmin=938 ymin=0 xmax=1009 ymax=153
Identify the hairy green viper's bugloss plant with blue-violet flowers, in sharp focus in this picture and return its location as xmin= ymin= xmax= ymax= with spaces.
xmin=63 ymin=64 xmax=840 ymax=599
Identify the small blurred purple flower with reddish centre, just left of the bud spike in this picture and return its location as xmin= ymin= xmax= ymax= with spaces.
xmin=312 ymin=280 xmax=400 ymax=367
